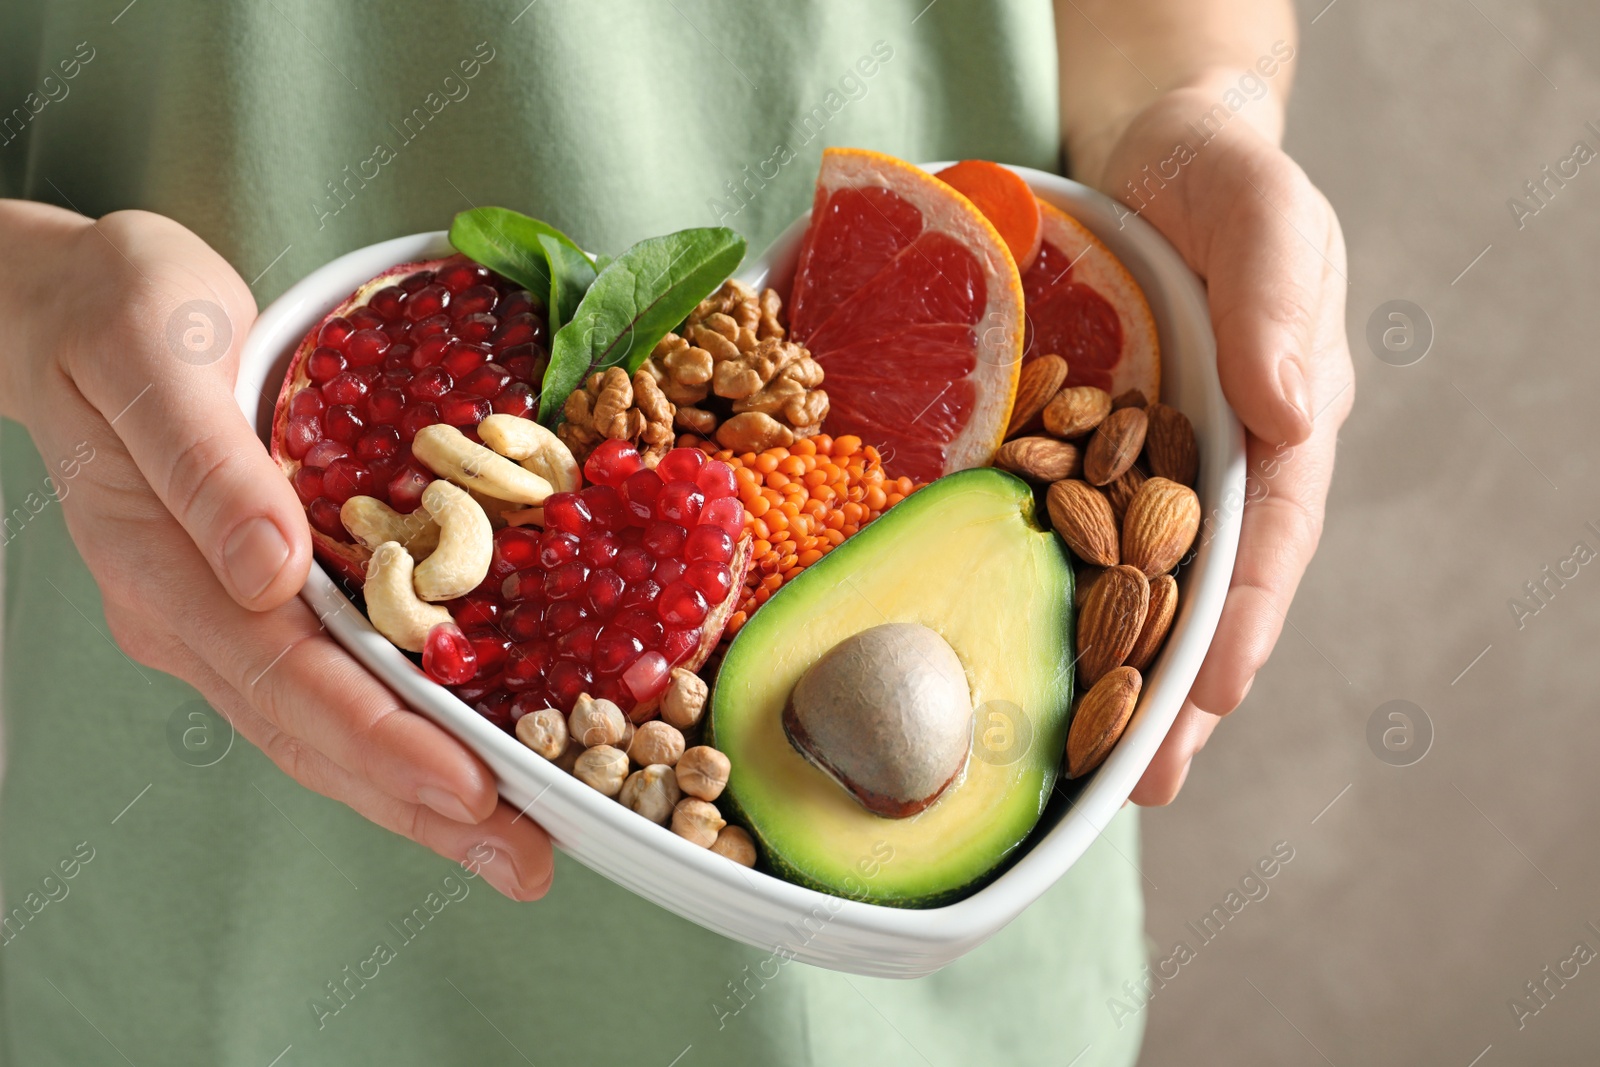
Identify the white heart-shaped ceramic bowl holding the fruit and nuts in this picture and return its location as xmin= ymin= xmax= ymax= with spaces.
xmin=237 ymin=165 xmax=1245 ymax=977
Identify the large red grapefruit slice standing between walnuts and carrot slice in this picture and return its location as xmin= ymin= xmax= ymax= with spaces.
xmin=789 ymin=149 xmax=1022 ymax=482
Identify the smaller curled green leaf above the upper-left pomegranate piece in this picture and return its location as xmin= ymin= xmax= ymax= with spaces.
xmin=450 ymin=208 xmax=595 ymax=331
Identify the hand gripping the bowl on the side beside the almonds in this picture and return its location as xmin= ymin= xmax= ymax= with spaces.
xmin=1078 ymin=81 xmax=1354 ymax=805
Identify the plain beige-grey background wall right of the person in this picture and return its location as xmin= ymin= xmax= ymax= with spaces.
xmin=1144 ymin=0 xmax=1600 ymax=1067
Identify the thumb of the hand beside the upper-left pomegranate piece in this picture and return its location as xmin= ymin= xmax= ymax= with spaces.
xmin=69 ymin=213 xmax=310 ymax=611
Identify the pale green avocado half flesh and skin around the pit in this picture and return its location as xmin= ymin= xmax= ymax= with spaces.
xmin=710 ymin=467 xmax=1074 ymax=907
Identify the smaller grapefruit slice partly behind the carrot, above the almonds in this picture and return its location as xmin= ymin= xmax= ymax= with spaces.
xmin=1024 ymin=200 xmax=1162 ymax=403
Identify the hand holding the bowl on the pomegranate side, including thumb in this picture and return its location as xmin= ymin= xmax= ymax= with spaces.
xmin=0 ymin=200 xmax=554 ymax=901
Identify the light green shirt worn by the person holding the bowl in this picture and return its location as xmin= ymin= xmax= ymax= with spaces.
xmin=0 ymin=0 xmax=1142 ymax=1067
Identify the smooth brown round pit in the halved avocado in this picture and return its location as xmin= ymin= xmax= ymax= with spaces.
xmin=784 ymin=622 xmax=973 ymax=819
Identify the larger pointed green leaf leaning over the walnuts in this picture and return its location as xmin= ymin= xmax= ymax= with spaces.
xmin=539 ymin=227 xmax=744 ymax=427
